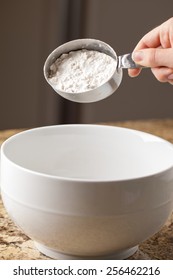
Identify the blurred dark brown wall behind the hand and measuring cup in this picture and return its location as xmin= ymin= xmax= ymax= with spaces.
xmin=0 ymin=0 xmax=173 ymax=129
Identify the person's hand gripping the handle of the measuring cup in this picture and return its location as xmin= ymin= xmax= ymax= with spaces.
xmin=128 ymin=18 xmax=173 ymax=85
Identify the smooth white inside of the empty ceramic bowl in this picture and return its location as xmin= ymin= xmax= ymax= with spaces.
xmin=3 ymin=125 xmax=173 ymax=181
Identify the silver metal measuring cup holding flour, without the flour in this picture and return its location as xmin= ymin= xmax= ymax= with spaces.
xmin=44 ymin=39 xmax=141 ymax=103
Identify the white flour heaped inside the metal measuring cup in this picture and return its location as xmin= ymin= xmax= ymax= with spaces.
xmin=49 ymin=49 xmax=116 ymax=93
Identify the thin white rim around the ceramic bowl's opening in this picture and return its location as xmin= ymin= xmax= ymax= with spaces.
xmin=0 ymin=124 xmax=173 ymax=183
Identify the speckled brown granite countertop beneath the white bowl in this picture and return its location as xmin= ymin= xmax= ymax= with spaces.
xmin=0 ymin=119 xmax=173 ymax=260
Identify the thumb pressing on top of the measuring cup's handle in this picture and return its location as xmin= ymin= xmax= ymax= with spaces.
xmin=132 ymin=48 xmax=173 ymax=68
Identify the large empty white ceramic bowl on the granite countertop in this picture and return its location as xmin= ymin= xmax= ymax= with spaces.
xmin=1 ymin=125 xmax=173 ymax=259
